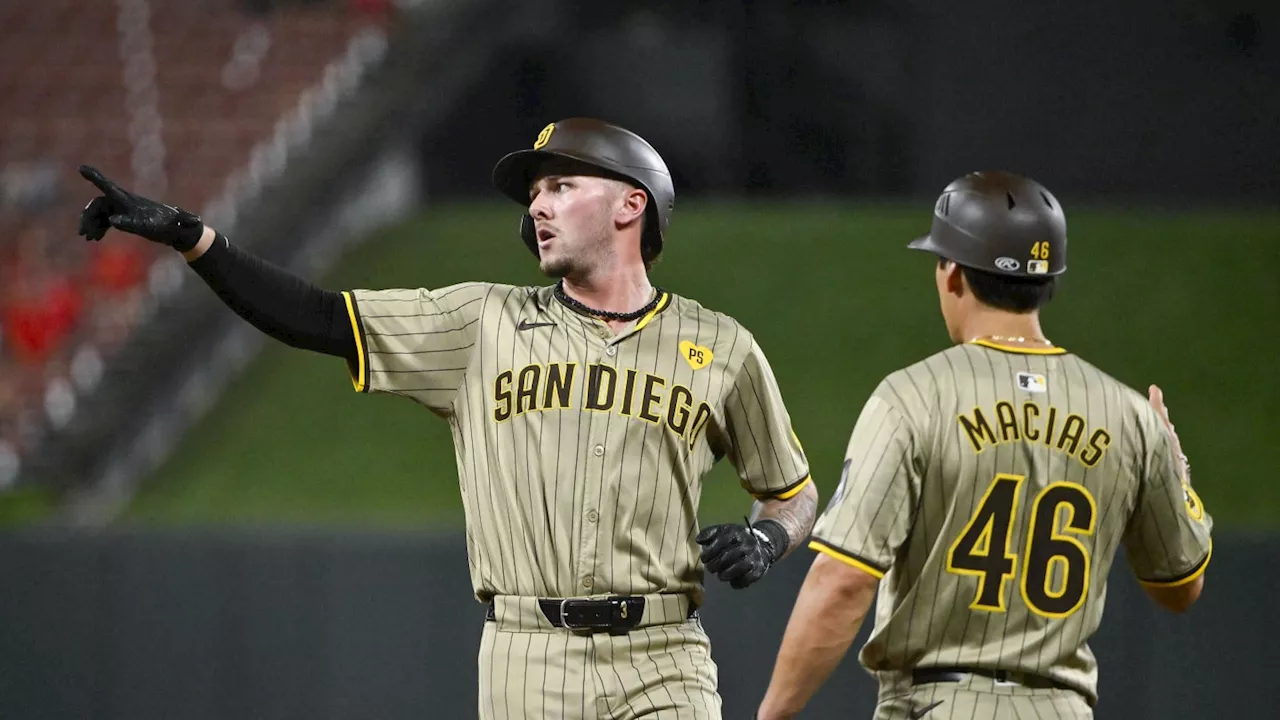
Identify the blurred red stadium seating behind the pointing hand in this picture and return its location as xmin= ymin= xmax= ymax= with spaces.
xmin=0 ymin=0 xmax=389 ymax=481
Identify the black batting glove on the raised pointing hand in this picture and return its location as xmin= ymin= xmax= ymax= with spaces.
xmin=79 ymin=165 xmax=205 ymax=252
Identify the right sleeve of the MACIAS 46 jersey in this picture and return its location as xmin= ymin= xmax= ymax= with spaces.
xmin=1124 ymin=421 xmax=1213 ymax=587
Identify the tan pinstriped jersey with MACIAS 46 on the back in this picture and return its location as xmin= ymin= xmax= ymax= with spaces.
xmin=812 ymin=342 xmax=1212 ymax=698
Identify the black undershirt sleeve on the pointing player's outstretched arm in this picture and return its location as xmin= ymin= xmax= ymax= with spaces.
xmin=189 ymin=234 xmax=356 ymax=364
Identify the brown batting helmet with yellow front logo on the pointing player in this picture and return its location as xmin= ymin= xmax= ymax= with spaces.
xmin=493 ymin=118 xmax=676 ymax=263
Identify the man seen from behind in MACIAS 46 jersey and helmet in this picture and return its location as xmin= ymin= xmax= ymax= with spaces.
xmin=759 ymin=172 xmax=1212 ymax=720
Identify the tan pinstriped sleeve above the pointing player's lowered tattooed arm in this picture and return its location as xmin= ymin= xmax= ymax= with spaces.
xmin=724 ymin=338 xmax=810 ymax=500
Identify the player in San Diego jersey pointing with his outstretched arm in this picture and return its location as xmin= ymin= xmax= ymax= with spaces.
xmin=81 ymin=118 xmax=817 ymax=719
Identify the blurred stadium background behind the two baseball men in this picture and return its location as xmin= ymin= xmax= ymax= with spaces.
xmin=0 ymin=0 xmax=1280 ymax=719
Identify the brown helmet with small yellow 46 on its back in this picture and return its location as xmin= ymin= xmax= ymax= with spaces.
xmin=908 ymin=172 xmax=1066 ymax=278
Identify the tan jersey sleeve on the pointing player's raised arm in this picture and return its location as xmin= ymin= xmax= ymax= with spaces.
xmin=343 ymin=283 xmax=488 ymax=413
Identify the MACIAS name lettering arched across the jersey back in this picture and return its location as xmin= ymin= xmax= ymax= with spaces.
xmin=957 ymin=401 xmax=1111 ymax=468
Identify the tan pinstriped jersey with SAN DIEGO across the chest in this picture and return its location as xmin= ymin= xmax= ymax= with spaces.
xmin=346 ymin=283 xmax=809 ymax=602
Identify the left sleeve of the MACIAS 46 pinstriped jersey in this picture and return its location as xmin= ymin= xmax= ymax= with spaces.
xmin=809 ymin=392 xmax=922 ymax=578
